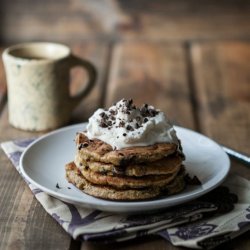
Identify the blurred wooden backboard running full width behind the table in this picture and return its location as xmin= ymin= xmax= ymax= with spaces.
xmin=0 ymin=0 xmax=250 ymax=43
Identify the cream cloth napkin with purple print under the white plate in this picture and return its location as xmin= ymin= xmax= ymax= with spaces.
xmin=1 ymin=139 xmax=250 ymax=249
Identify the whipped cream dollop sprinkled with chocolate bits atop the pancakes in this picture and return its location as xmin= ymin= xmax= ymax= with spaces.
xmin=85 ymin=99 xmax=179 ymax=149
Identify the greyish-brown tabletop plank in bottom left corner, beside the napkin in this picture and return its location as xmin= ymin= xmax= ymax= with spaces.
xmin=0 ymin=147 xmax=71 ymax=250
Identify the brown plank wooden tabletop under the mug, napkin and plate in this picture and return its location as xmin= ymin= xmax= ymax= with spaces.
xmin=0 ymin=40 xmax=250 ymax=250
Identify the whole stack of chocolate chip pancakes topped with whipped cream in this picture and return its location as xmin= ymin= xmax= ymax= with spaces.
xmin=66 ymin=99 xmax=188 ymax=200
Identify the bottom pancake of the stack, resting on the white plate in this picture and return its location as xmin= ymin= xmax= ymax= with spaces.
xmin=65 ymin=162 xmax=185 ymax=201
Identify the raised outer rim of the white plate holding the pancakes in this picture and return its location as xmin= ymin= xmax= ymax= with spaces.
xmin=19 ymin=122 xmax=231 ymax=213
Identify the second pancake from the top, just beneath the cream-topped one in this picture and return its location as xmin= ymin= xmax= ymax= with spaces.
xmin=75 ymin=153 xmax=182 ymax=177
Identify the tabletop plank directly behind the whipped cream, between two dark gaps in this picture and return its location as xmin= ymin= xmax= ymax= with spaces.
xmin=106 ymin=42 xmax=194 ymax=128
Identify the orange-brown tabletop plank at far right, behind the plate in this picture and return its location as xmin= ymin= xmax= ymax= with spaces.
xmin=191 ymin=42 xmax=250 ymax=154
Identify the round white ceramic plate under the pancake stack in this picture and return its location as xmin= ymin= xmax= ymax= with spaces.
xmin=20 ymin=123 xmax=230 ymax=213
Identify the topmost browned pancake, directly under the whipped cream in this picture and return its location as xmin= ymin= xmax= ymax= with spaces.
xmin=76 ymin=133 xmax=178 ymax=166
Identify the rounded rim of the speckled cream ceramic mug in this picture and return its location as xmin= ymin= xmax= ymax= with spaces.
xmin=2 ymin=42 xmax=71 ymax=64
